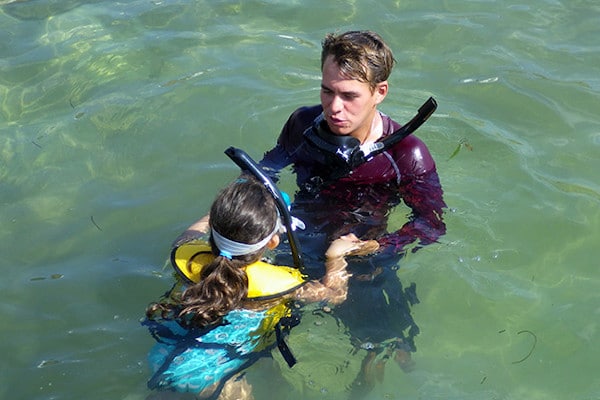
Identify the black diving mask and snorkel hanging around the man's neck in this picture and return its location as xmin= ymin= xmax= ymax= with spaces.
xmin=304 ymin=97 xmax=437 ymax=178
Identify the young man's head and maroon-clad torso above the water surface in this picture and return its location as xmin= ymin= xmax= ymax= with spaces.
xmin=261 ymin=31 xmax=446 ymax=254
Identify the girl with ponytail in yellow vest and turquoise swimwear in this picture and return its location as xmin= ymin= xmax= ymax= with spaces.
xmin=145 ymin=175 xmax=378 ymax=399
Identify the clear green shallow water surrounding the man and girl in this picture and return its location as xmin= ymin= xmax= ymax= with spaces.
xmin=0 ymin=0 xmax=600 ymax=400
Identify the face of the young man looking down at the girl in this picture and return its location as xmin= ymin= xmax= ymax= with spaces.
xmin=321 ymin=56 xmax=388 ymax=143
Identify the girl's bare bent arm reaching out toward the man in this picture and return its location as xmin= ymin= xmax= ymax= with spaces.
xmin=295 ymin=233 xmax=379 ymax=304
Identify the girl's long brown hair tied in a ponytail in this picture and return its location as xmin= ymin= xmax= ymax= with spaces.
xmin=146 ymin=175 xmax=278 ymax=327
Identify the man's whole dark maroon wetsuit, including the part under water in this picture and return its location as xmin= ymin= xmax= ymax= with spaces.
xmin=260 ymin=106 xmax=446 ymax=348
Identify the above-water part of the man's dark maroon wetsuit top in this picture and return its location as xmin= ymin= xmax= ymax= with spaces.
xmin=261 ymin=106 xmax=446 ymax=252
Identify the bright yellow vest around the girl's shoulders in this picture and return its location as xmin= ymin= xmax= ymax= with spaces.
xmin=171 ymin=241 xmax=306 ymax=300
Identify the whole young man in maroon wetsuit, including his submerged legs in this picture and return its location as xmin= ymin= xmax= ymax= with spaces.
xmin=261 ymin=31 xmax=446 ymax=389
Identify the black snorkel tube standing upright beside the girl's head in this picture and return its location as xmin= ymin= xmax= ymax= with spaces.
xmin=225 ymin=147 xmax=304 ymax=269
